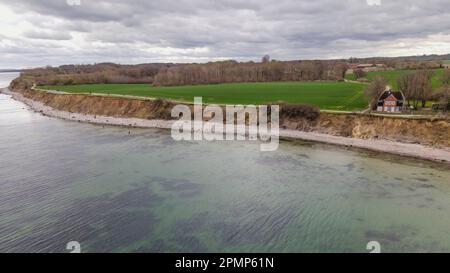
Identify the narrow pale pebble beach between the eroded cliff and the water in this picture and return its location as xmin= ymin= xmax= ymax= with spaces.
xmin=0 ymin=88 xmax=450 ymax=164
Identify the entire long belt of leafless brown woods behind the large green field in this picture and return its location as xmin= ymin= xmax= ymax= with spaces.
xmin=17 ymin=60 xmax=347 ymax=86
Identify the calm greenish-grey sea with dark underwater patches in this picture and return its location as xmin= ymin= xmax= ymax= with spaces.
xmin=0 ymin=73 xmax=450 ymax=252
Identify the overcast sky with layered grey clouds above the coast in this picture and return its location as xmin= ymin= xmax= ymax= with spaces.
xmin=0 ymin=0 xmax=450 ymax=68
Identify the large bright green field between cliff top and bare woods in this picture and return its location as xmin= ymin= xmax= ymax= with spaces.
xmin=39 ymin=82 xmax=368 ymax=110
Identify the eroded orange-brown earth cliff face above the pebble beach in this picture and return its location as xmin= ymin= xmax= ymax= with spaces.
xmin=10 ymin=86 xmax=450 ymax=147
